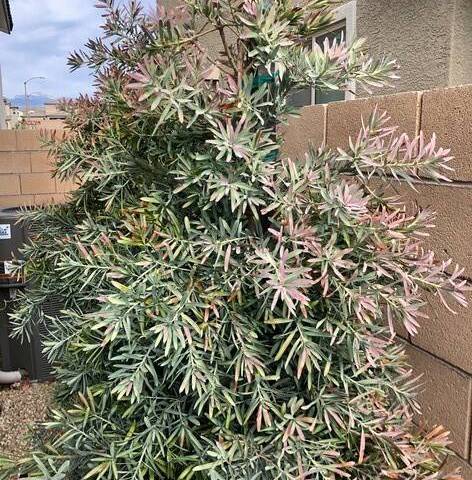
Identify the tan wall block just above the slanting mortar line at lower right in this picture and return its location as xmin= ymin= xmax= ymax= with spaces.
xmin=411 ymin=295 xmax=472 ymax=374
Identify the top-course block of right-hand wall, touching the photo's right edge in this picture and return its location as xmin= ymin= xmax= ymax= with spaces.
xmin=421 ymin=85 xmax=472 ymax=181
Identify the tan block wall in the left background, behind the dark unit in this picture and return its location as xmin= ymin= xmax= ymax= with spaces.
xmin=0 ymin=130 xmax=73 ymax=208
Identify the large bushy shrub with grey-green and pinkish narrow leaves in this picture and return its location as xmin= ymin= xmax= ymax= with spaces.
xmin=2 ymin=0 xmax=466 ymax=480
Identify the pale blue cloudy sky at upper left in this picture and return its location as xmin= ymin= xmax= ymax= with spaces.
xmin=0 ymin=0 xmax=155 ymax=98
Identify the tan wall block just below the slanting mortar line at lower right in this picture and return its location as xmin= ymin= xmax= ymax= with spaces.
xmin=406 ymin=345 xmax=472 ymax=458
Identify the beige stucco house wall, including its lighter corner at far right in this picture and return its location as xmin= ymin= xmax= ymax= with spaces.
xmin=163 ymin=0 xmax=472 ymax=94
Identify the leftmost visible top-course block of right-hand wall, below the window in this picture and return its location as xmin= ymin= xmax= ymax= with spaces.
xmin=279 ymin=105 xmax=326 ymax=159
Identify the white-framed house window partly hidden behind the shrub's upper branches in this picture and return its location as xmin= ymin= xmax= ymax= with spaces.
xmin=289 ymin=0 xmax=356 ymax=107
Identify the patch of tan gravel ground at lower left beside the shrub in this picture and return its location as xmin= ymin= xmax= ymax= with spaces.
xmin=0 ymin=382 xmax=54 ymax=458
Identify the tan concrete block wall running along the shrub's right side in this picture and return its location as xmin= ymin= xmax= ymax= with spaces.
xmin=281 ymin=85 xmax=472 ymax=480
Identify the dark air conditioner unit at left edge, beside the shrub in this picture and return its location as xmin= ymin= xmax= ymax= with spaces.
xmin=0 ymin=208 xmax=53 ymax=380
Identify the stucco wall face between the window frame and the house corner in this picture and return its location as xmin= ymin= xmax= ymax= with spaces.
xmin=357 ymin=0 xmax=454 ymax=91
